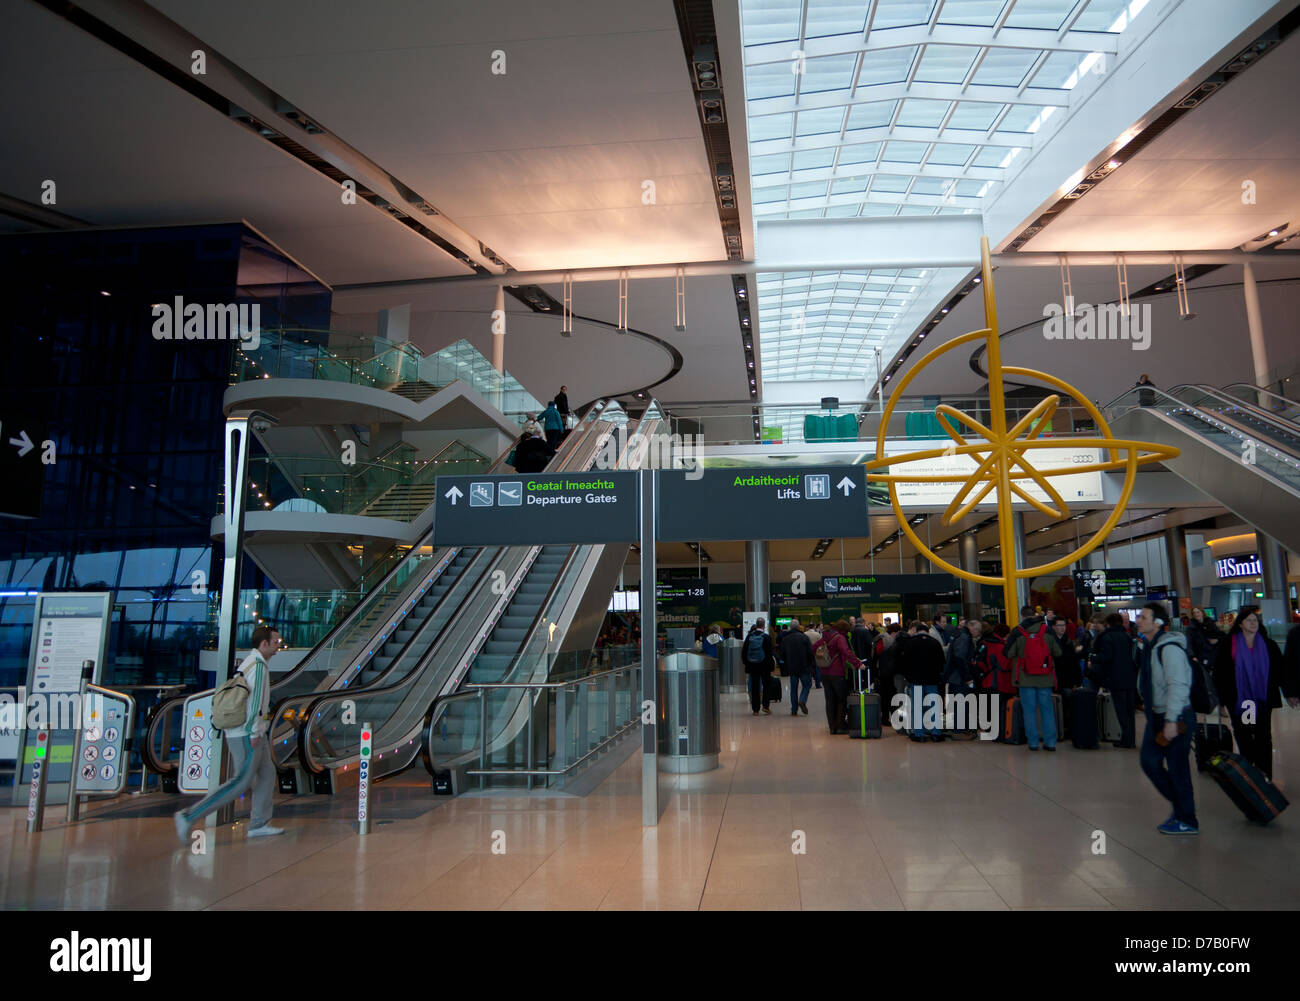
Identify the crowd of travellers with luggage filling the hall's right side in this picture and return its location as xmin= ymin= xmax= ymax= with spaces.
xmin=728 ymin=602 xmax=1300 ymax=835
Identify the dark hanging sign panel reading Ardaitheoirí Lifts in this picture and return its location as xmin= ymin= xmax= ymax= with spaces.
xmin=659 ymin=465 xmax=867 ymax=542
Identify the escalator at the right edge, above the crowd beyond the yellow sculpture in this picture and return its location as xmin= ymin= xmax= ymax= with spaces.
xmin=1102 ymin=386 xmax=1300 ymax=550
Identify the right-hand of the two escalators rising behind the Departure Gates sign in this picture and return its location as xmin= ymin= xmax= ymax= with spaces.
xmin=289 ymin=403 xmax=662 ymax=780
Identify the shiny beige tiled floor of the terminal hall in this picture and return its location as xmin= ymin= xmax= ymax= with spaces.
xmin=0 ymin=692 xmax=1300 ymax=910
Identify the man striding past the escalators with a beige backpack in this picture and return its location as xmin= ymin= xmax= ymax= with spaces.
xmin=173 ymin=625 xmax=285 ymax=844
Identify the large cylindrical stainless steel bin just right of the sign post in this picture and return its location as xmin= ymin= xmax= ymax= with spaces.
xmin=658 ymin=653 xmax=722 ymax=774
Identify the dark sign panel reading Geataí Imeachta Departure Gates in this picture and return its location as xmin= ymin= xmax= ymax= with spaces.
xmin=433 ymin=469 xmax=640 ymax=546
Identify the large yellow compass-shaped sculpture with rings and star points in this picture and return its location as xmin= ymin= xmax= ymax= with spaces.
xmin=866 ymin=237 xmax=1178 ymax=624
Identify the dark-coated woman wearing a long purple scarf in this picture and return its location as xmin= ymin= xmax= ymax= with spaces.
xmin=1214 ymin=606 xmax=1300 ymax=779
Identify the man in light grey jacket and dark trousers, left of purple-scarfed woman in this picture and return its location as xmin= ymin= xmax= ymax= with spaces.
xmin=1136 ymin=602 xmax=1200 ymax=835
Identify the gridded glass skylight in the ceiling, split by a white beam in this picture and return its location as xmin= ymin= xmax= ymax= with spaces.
xmin=741 ymin=0 xmax=1170 ymax=395
